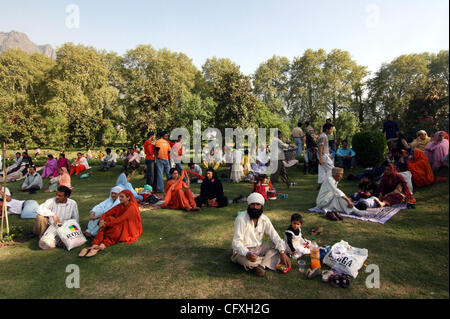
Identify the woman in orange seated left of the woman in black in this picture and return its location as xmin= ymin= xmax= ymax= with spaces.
xmin=161 ymin=168 xmax=199 ymax=211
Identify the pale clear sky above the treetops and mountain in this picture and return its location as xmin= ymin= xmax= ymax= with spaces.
xmin=0 ymin=0 xmax=449 ymax=74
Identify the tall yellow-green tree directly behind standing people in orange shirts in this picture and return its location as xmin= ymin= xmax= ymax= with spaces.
xmin=121 ymin=45 xmax=198 ymax=142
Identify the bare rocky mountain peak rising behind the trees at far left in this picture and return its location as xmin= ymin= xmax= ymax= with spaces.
xmin=0 ymin=31 xmax=56 ymax=59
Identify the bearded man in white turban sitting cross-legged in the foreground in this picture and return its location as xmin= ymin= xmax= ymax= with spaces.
xmin=231 ymin=193 xmax=291 ymax=277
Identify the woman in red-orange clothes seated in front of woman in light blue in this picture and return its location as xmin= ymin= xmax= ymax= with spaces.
xmin=78 ymin=190 xmax=142 ymax=257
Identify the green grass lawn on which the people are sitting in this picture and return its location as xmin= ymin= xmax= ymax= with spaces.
xmin=0 ymin=162 xmax=449 ymax=299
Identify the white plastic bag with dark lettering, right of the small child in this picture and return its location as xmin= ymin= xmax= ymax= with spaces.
xmin=323 ymin=240 xmax=369 ymax=278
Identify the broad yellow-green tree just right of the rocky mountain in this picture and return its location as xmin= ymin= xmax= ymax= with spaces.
xmin=45 ymin=43 xmax=118 ymax=147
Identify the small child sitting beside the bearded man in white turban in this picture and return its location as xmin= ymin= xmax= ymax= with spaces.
xmin=284 ymin=214 xmax=311 ymax=259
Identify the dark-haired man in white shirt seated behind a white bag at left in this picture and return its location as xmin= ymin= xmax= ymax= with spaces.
xmin=33 ymin=186 xmax=79 ymax=237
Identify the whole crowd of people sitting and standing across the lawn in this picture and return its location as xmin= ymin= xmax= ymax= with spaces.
xmin=0 ymin=116 xmax=448 ymax=268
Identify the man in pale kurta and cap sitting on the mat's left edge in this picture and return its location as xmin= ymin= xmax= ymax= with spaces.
xmin=316 ymin=167 xmax=360 ymax=215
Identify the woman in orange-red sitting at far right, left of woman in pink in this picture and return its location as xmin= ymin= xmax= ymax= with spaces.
xmin=392 ymin=148 xmax=434 ymax=187
